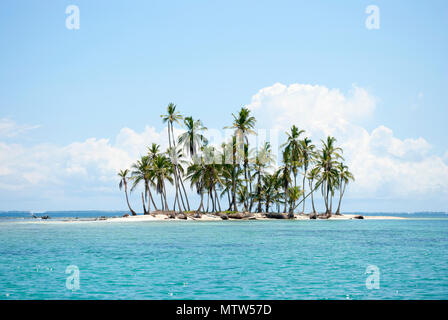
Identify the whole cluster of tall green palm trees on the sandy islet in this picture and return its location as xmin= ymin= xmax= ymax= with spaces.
xmin=118 ymin=103 xmax=354 ymax=217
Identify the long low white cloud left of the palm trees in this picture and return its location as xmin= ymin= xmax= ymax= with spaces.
xmin=0 ymin=126 xmax=172 ymax=190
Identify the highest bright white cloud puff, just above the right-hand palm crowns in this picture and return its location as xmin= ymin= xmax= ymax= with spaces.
xmin=248 ymin=83 xmax=375 ymax=134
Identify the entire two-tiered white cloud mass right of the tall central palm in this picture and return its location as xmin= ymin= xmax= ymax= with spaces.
xmin=248 ymin=83 xmax=448 ymax=198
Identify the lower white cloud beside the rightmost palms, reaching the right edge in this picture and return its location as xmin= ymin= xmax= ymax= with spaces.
xmin=342 ymin=127 xmax=448 ymax=198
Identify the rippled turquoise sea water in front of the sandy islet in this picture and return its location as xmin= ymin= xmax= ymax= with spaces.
xmin=0 ymin=219 xmax=448 ymax=299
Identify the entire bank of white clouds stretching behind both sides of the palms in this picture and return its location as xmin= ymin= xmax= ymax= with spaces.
xmin=0 ymin=83 xmax=448 ymax=209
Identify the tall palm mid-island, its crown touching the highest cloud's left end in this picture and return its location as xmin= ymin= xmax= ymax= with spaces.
xmin=226 ymin=107 xmax=256 ymax=211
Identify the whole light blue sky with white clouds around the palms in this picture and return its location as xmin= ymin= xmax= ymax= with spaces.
xmin=0 ymin=0 xmax=448 ymax=212
